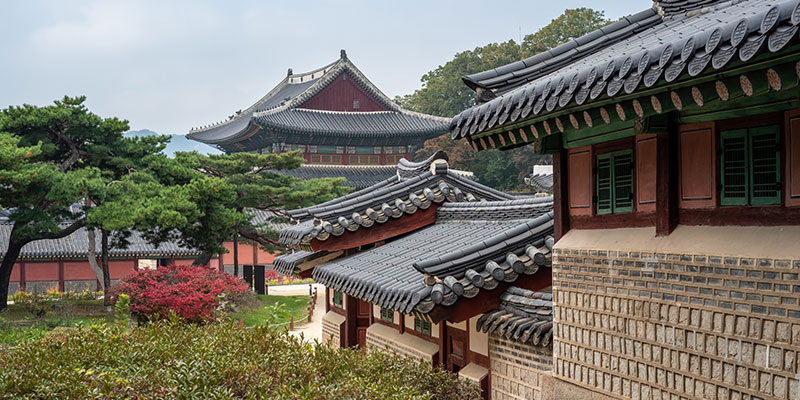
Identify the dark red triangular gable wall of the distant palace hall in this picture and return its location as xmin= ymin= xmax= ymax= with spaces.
xmin=300 ymin=72 xmax=389 ymax=111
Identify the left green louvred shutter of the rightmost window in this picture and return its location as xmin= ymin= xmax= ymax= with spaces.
xmin=720 ymin=129 xmax=752 ymax=206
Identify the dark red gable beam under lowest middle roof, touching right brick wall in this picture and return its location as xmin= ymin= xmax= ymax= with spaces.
xmin=428 ymin=268 xmax=553 ymax=324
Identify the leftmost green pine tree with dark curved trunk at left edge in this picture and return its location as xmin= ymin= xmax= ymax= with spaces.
xmin=0 ymin=97 xmax=135 ymax=310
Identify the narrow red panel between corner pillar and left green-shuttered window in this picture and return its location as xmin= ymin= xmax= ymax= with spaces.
xmin=567 ymin=146 xmax=594 ymax=215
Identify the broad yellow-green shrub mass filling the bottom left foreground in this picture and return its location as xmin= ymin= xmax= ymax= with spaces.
xmin=0 ymin=318 xmax=478 ymax=400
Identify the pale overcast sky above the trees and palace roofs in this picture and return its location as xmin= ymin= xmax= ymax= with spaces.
xmin=0 ymin=0 xmax=636 ymax=134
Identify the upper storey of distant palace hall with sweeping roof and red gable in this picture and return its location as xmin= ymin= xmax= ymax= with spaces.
xmin=187 ymin=50 xmax=449 ymax=166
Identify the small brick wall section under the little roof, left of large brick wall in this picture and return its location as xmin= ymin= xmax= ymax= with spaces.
xmin=489 ymin=335 xmax=553 ymax=400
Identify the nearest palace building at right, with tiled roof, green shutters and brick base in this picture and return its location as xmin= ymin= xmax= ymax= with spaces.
xmin=450 ymin=0 xmax=800 ymax=399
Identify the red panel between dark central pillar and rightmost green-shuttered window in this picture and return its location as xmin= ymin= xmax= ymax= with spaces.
xmin=678 ymin=123 xmax=717 ymax=208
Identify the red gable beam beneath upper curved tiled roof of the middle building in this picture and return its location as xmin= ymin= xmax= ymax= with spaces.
xmin=309 ymin=203 xmax=439 ymax=252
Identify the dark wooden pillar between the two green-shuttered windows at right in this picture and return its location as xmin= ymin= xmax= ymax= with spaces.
xmin=656 ymin=122 xmax=678 ymax=236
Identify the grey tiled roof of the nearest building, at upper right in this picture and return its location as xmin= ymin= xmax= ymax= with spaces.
xmin=449 ymin=0 xmax=800 ymax=141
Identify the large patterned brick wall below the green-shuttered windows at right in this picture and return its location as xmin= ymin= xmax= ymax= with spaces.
xmin=553 ymin=246 xmax=800 ymax=399
